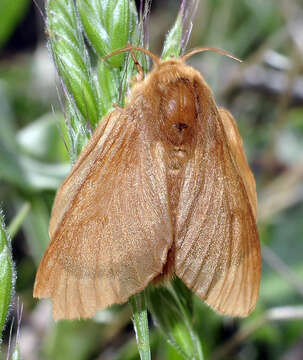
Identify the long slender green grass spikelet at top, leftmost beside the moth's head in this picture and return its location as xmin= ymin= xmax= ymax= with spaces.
xmin=46 ymin=0 xmax=100 ymax=128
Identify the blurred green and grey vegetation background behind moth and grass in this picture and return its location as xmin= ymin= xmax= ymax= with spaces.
xmin=0 ymin=0 xmax=303 ymax=360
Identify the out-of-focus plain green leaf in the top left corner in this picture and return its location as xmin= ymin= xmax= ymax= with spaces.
xmin=0 ymin=0 xmax=30 ymax=47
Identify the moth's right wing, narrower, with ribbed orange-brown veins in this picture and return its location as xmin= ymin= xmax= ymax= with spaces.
xmin=175 ymin=109 xmax=261 ymax=316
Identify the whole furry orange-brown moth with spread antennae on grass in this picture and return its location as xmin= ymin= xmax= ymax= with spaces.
xmin=34 ymin=46 xmax=261 ymax=320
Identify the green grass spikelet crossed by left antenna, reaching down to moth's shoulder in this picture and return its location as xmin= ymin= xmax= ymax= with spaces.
xmin=77 ymin=0 xmax=147 ymax=111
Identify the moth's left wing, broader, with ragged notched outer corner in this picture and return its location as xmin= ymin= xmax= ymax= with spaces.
xmin=34 ymin=111 xmax=172 ymax=320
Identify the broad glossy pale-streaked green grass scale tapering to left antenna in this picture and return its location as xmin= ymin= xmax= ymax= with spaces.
xmin=77 ymin=0 xmax=130 ymax=68
